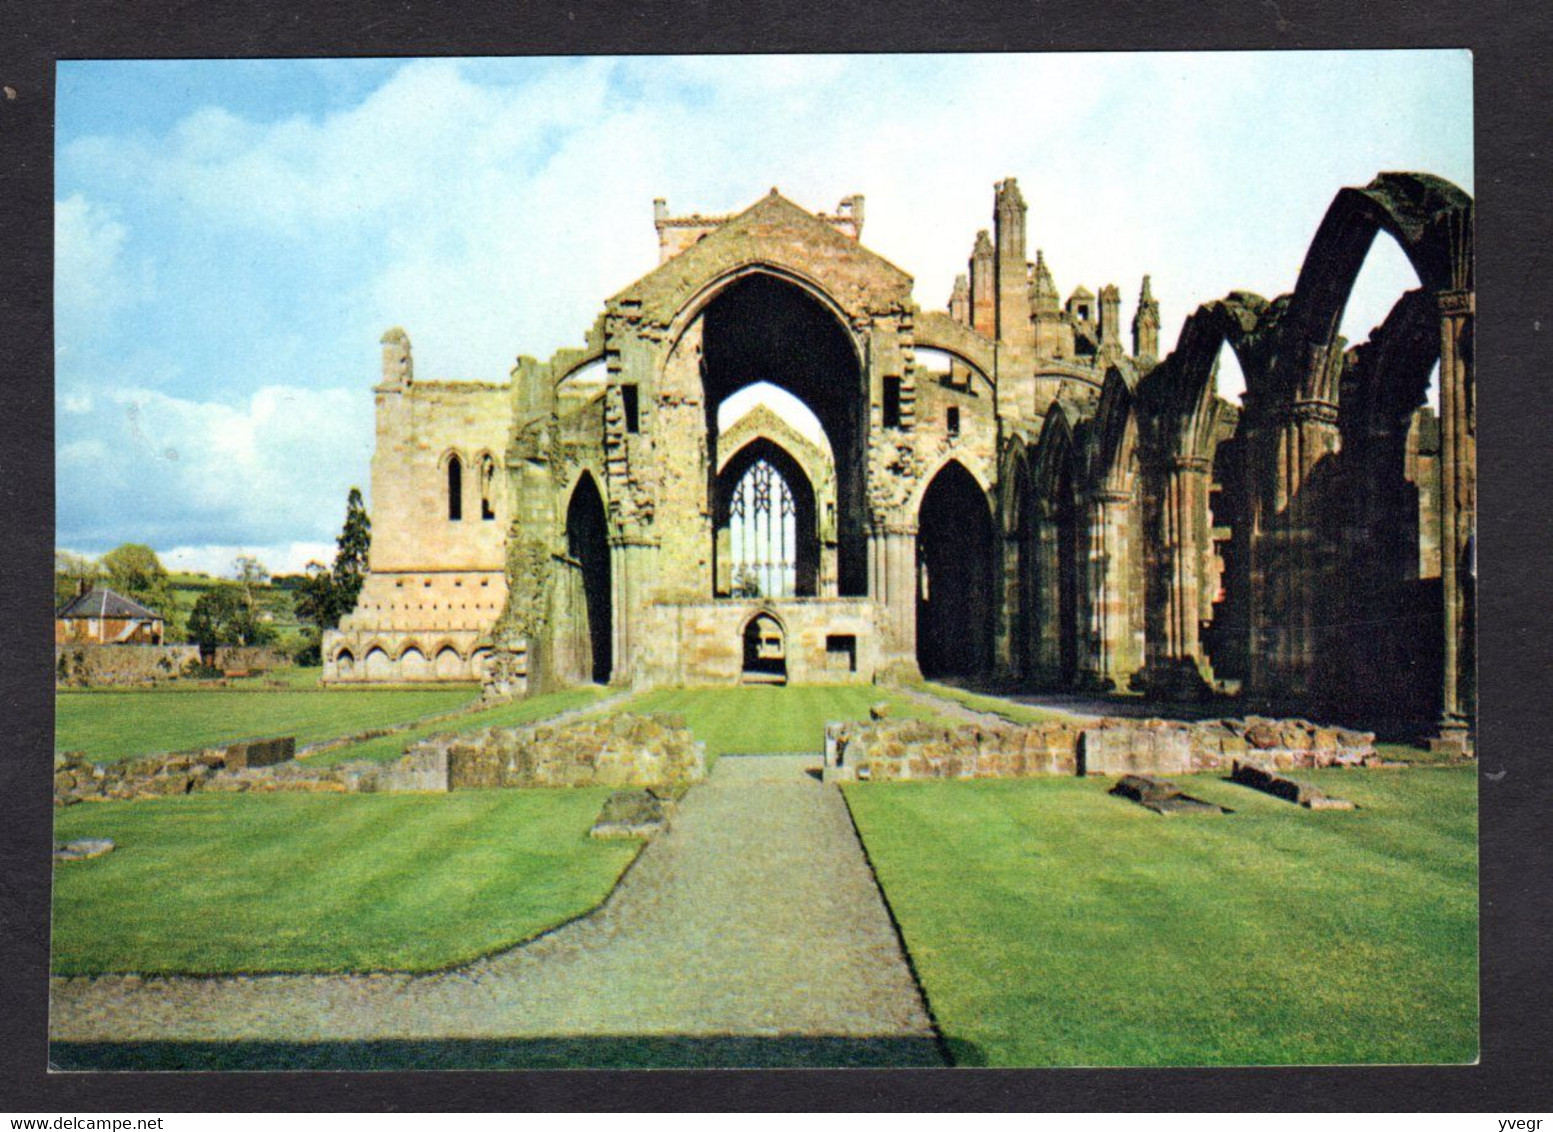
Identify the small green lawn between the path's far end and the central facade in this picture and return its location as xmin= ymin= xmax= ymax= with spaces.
xmin=623 ymin=685 xmax=933 ymax=762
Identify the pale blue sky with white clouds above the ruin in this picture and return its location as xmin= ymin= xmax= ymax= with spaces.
xmin=56 ymin=51 xmax=1474 ymax=571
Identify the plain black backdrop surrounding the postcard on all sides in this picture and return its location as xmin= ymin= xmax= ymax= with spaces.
xmin=0 ymin=0 xmax=1553 ymax=1115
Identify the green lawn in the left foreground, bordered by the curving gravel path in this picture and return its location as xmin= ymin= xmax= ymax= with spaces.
xmin=53 ymin=789 xmax=638 ymax=974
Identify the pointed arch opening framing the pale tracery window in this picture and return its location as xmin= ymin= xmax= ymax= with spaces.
xmin=716 ymin=436 xmax=820 ymax=598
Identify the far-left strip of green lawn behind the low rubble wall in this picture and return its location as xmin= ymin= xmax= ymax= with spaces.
xmin=54 ymin=686 xmax=478 ymax=759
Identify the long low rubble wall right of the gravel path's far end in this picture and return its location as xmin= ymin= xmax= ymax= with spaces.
xmin=825 ymin=716 xmax=1379 ymax=781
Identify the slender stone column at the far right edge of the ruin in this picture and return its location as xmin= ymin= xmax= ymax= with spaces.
xmin=1440 ymin=290 xmax=1477 ymax=736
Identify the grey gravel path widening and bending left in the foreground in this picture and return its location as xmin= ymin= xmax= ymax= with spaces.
xmin=50 ymin=755 xmax=936 ymax=1062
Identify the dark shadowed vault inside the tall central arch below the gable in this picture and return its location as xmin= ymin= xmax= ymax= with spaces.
xmin=700 ymin=270 xmax=868 ymax=596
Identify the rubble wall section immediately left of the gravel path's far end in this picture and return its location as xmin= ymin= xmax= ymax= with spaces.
xmin=405 ymin=714 xmax=707 ymax=790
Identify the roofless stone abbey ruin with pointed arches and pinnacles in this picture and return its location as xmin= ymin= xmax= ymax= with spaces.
xmin=325 ymin=172 xmax=1477 ymax=739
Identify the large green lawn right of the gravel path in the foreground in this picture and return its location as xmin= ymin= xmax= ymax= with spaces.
xmin=846 ymin=769 xmax=1478 ymax=1065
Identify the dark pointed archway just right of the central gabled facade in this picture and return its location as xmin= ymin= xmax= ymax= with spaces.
xmin=916 ymin=461 xmax=994 ymax=677
